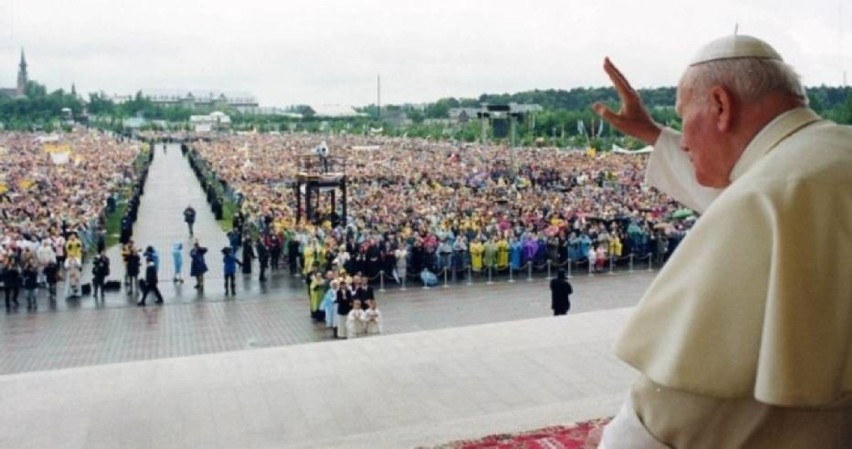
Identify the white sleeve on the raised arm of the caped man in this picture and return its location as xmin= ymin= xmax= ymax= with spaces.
xmin=645 ymin=128 xmax=721 ymax=212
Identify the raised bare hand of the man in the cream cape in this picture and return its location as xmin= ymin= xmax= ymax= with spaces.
xmin=592 ymin=58 xmax=660 ymax=145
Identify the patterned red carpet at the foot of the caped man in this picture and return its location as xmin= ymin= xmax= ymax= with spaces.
xmin=434 ymin=418 xmax=611 ymax=449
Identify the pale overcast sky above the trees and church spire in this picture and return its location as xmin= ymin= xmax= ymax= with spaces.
xmin=0 ymin=0 xmax=852 ymax=106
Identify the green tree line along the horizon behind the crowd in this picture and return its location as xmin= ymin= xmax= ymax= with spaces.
xmin=0 ymin=81 xmax=852 ymax=146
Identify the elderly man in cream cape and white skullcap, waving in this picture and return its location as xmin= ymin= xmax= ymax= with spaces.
xmin=594 ymin=35 xmax=852 ymax=449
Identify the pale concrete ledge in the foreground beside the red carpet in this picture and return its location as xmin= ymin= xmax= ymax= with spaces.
xmin=0 ymin=309 xmax=635 ymax=448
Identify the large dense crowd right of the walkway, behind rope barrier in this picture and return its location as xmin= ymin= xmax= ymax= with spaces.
xmin=190 ymin=134 xmax=692 ymax=281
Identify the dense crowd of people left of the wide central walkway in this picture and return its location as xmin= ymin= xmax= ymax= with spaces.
xmin=0 ymin=130 xmax=146 ymax=308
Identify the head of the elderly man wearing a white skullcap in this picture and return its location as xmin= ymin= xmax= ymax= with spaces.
xmin=676 ymin=36 xmax=808 ymax=188
